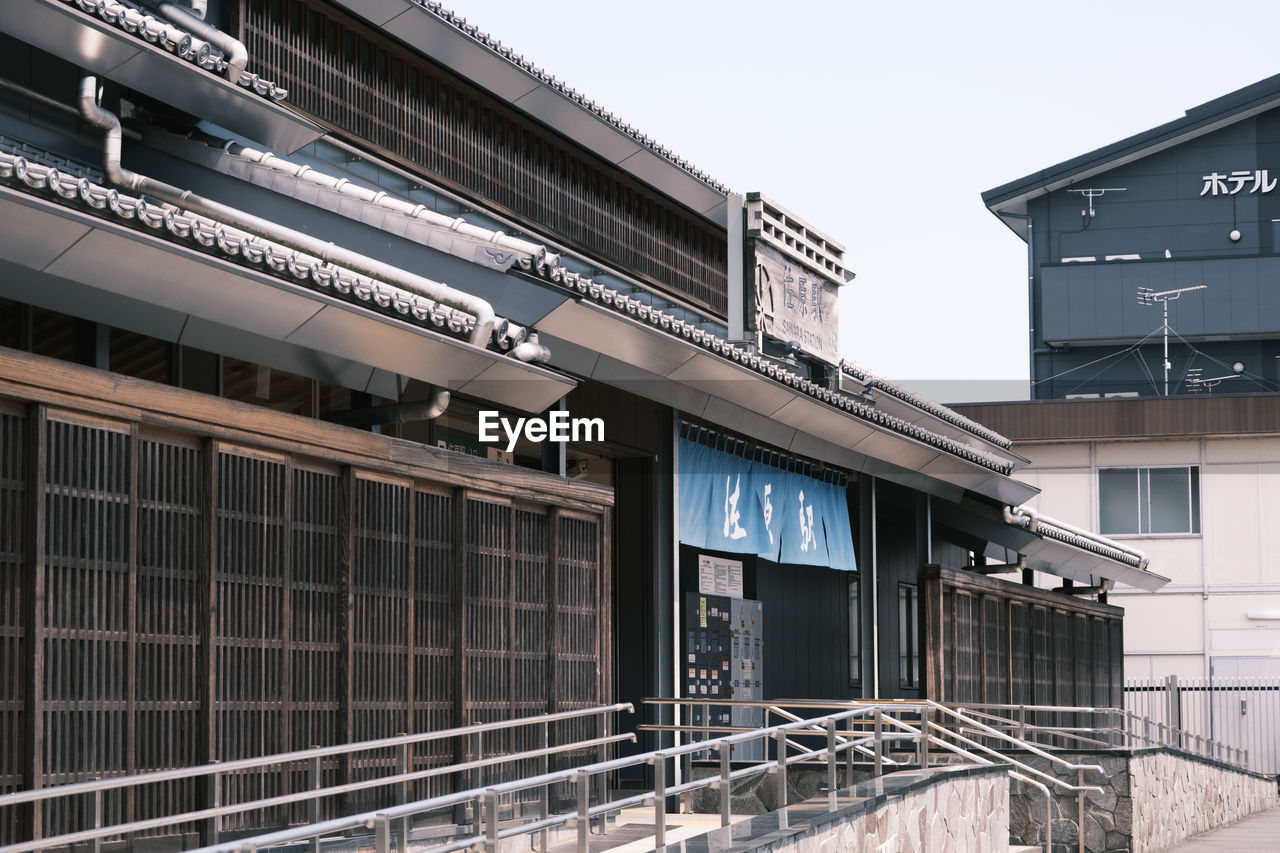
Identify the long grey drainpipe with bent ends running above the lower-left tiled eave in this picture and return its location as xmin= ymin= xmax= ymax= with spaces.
xmin=79 ymin=74 xmax=495 ymax=347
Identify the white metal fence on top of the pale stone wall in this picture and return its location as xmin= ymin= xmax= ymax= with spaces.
xmin=1124 ymin=675 xmax=1280 ymax=774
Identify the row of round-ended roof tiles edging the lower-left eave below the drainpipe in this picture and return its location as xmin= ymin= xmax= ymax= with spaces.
xmin=0 ymin=142 xmax=475 ymax=339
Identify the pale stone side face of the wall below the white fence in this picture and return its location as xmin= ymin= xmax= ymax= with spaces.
xmin=1129 ymin=751 xmax=1280 ymax=853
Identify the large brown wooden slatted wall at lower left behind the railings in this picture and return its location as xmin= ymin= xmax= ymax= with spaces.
xmin=0 ymin=351 xmax=612 ymax=844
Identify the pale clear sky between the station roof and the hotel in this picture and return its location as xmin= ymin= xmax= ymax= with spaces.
xmin=444 ymin=0 xmax=1280 ymax=402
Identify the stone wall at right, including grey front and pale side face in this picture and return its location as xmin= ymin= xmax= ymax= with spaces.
xmin=1009 ymin=748 xmax=1280 ymax=853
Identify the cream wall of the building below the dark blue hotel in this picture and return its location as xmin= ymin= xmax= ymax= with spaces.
xmin=1015 ymin=437 xmax=1280 ymax=678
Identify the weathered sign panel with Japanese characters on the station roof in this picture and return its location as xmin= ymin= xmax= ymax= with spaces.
xmin=755 ymin=241 xmax=840 ymax=364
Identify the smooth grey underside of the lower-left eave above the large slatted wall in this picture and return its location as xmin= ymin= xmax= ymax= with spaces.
xmin=0 ymin=178 xmax=577 ymax=411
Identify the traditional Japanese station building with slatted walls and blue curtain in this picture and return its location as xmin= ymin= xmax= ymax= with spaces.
xmin=0 ymin=0 xmax=1164 ymax=838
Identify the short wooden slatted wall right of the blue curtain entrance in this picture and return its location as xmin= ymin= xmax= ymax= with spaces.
xmin=924 ymin=566 xmax=1124 ymax=725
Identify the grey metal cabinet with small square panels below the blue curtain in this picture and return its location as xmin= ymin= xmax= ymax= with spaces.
xmin=685 ymin=593 xmax=764 ymax=760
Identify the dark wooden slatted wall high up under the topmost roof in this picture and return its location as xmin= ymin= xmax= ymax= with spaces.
xmin=237 ymin=0 xmax=728 ymax=314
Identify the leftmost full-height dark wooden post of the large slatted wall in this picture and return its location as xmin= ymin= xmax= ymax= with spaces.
xmin=20 ymin=406 xmax=49 ymax=839
